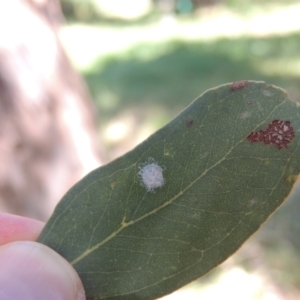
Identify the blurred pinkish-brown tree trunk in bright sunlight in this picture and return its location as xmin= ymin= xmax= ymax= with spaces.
xmin=0 ymin=0 xmax=101 ymax=220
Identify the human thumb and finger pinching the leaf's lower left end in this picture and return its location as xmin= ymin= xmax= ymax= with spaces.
xmin=0 ymin=213 xmax=85 ymax=300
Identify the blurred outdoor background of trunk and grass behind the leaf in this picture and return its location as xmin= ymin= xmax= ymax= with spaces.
xmin=0 ymin=0 xmax=300 ymax=300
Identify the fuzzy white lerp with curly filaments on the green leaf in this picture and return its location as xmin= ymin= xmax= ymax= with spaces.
xmin=138 ymin=157 xmax=166 ymax=193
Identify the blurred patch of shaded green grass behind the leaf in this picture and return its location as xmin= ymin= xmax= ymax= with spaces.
xmin=84 ymin=34 xmax=300 ymax=122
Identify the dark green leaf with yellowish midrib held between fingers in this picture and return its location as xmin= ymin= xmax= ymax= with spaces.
xmin=38 ymin=81 xmax=300 ymax=300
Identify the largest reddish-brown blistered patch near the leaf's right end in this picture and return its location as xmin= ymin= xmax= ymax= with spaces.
xmin=247 ymin=120 xmax=295 ymax=149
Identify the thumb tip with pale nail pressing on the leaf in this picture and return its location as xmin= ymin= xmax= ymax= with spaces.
xmin=0 ymin=241 xmax=85 ymax=300
